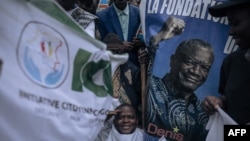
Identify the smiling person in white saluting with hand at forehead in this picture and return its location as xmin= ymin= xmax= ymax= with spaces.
xmin=95 ymin=103 xmax=143 ymax=141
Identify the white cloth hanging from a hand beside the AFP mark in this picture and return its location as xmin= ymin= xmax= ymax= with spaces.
xmin=206 ymin=108 xmax=237 ymax=141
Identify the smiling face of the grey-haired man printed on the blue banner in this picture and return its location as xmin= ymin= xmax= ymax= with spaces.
xmin=171 ymin=47 xmax=213 ymax=91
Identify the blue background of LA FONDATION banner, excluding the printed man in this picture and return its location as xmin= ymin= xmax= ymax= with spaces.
xmin=140 ymin=0 xmax=237 ymax=99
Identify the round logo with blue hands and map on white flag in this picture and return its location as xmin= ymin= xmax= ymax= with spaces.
xmin=17 ymin=21 xmax=69 ymax=88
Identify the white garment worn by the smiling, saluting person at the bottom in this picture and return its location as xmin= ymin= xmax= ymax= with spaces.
xmin=106 ymin=125 xmax=143 ymax=141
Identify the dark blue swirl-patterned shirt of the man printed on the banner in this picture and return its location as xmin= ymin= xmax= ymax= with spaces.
xmin=145 ymin=75 xmax=208 ymax=141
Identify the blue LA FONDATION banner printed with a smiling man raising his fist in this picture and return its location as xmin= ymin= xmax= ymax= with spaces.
xmin=140 ymin=0 xmax=237 ymax=141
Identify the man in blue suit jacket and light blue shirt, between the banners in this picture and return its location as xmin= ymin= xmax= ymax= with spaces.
xmin=97 ymin=0 xmax=140 ymax=67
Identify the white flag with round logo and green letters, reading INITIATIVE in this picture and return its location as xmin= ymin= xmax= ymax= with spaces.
xmin=0 ymin=0 xmax=128 ymax=141
